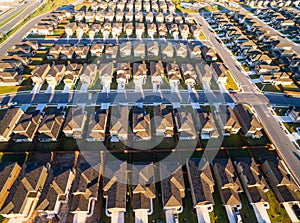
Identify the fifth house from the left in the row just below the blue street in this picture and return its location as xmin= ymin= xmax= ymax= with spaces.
xmin=86 ymin=109 xmax=108 ymax=141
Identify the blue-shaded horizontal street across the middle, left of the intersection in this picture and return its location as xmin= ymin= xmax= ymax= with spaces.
xmin=0 ymin=91 xmax=233 ymax=105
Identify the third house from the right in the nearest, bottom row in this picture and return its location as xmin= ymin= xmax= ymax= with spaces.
xmin=212 ymin=158 xmax=243 ymax=222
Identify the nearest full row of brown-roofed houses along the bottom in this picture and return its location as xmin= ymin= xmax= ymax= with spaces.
xmin=0 ymin=153 xmax=299 ymax=221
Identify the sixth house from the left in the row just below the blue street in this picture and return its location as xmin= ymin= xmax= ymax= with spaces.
xmin=109 ymin=106 xmax=129 ymax=142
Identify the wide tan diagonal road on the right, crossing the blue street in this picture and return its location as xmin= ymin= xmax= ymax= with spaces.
xmin=193 ymin=14 xmax=300 ymax=183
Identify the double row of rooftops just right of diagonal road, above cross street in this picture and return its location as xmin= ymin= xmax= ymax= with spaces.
xmin=209 ymin=12 xmax=299 ymax=85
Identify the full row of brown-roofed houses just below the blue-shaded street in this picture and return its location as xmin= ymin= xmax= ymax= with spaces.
xmin=0 ymin=104 xmax=262 ymax=142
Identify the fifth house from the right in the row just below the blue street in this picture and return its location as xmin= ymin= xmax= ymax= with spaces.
xmin=154 ymin=104 xmax=174 ymax=137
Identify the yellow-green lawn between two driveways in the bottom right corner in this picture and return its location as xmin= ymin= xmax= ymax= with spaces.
xmin=266 ymin=190 xmax=291 ymax=223
